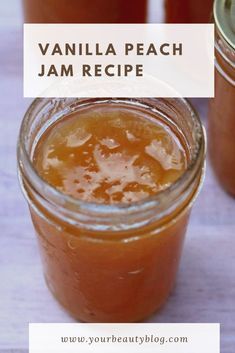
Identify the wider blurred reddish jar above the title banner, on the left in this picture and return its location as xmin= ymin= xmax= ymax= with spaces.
xmin=23 ymin=0 xmax=148 ymax=23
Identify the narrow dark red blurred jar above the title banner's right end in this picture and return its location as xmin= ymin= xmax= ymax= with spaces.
xmin=165 ymin=0 xmax=213 ymax=23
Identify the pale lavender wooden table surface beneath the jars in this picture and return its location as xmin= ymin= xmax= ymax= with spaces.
xmin=0 ymin=0 xmax=235 ymax=353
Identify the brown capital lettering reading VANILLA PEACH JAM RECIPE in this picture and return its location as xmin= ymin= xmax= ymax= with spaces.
xmin=37 ymin=43 xmax=183 ymax=77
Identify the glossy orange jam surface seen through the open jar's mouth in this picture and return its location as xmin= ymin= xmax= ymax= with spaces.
xmin=33 ymin=107 xmax=187 ymax=204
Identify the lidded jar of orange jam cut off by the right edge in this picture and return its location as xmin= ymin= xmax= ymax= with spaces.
xmin=208 ymin=0 xmax=235 ymax=196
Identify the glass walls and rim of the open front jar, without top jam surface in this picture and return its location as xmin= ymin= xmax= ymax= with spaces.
xmin=18 ymin=98 xmax=205 ymax=322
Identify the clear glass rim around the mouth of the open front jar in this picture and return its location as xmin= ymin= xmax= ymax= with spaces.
xmin=17 ymin=98 xmax=206 ymax=228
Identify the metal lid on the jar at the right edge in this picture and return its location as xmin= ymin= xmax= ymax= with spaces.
xmin=214 ymin=0 xmax=235 ymax=50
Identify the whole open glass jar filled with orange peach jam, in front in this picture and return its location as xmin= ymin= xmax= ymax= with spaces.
xmin=18 ymin=98 xmax=205 ymax=322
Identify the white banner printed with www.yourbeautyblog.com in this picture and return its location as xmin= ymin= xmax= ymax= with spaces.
xmin=29 ymin=323 xmax=220 ymax=353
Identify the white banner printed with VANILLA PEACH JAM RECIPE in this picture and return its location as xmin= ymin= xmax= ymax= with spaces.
xmin=24 ymin=24 xmax=214 ymax=97
